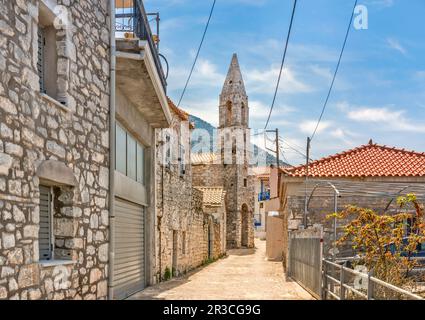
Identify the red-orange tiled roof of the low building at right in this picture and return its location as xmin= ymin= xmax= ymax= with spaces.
xmin=285 ymin=142 xmax=425 ymax=178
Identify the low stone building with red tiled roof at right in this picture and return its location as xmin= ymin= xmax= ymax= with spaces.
xmin=266 ymin=140 xmax=425 ymax=263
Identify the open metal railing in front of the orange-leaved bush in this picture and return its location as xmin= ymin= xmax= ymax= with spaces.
xmin=322 ymin=259 xmax=425 ymax=300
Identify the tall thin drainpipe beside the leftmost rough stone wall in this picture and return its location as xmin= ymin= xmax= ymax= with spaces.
xmin=108 ymin=0 xmax=116 ymax=300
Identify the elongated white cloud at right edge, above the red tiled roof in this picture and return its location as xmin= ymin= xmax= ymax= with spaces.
xmin=347 ymin=107 xmax=425 ymax=133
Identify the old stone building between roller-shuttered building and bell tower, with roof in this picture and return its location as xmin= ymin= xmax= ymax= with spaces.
xmin=155 ymin=100 xmax=226 ymax=281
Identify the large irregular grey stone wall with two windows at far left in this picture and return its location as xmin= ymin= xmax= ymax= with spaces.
xmin=0 ymin=0 xmax=110 ymax=299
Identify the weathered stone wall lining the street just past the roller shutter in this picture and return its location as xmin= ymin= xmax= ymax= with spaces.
xmin=155 ymin=118 xmax=217 ymax=282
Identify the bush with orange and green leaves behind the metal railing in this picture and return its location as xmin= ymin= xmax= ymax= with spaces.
xmin=328 ymin=194 xmax=425 ymax=294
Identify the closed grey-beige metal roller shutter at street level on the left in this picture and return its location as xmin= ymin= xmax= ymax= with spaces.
xmin=113 ymin=199 xmax=145 ymax=299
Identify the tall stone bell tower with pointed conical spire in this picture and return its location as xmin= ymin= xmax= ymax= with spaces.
xmin=218 ymin=54 xmax=254 ymax=249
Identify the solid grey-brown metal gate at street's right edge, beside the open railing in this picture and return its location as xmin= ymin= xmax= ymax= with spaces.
xmin=287 ymin=228 xmax=323 ymax=299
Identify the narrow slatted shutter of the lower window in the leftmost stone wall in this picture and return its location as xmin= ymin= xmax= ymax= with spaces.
xmin=38 ymin=186 xmax=52 ymax=260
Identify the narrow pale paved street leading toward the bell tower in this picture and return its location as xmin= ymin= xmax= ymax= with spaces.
xmin=129 ymin=239 xmax=313 ymax=300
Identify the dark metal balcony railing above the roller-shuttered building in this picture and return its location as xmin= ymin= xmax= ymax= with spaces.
xmin=115 ymin=0 xmax=167 ymax=92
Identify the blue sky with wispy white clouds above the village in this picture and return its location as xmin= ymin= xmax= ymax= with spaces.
xmin=145 ymin=0 xmax=425 ymax=164
